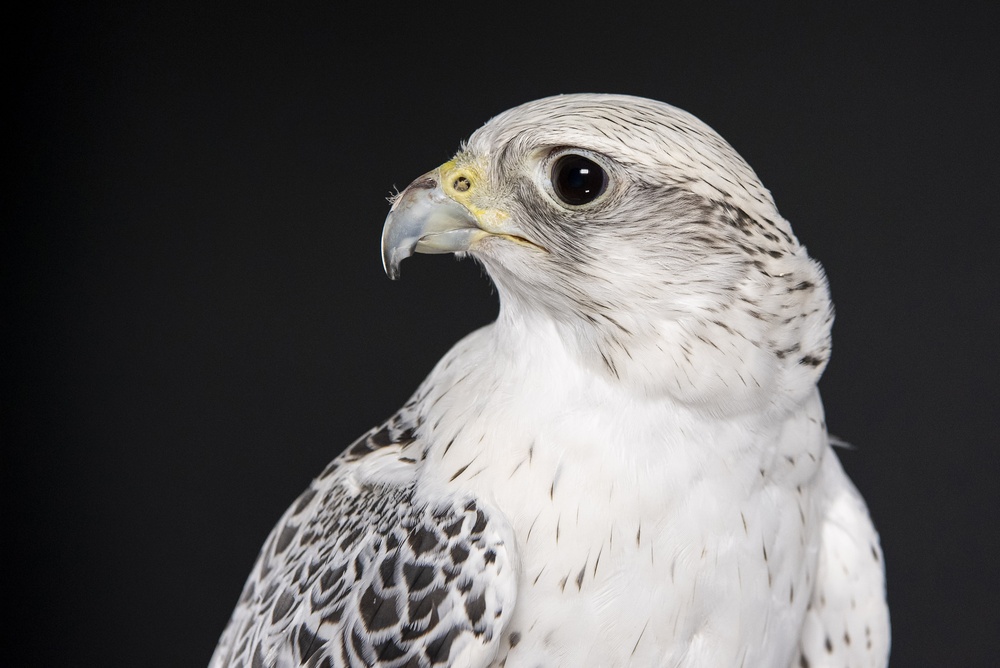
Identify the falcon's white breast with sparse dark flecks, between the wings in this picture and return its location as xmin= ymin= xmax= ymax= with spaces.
xmin=408 ymin=328 xmax=825 ymax=666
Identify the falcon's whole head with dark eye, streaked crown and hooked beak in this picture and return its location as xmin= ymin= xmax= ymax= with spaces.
xmin=382 ymin=95 xmax=832 ymax=413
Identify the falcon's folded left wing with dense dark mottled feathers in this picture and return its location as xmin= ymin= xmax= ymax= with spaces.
xmin=211 ymin=416 xmax=516 ymax=668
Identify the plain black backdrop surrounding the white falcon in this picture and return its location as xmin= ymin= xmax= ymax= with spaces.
xmin=9 ymin=2 xmax=1000 ymax=666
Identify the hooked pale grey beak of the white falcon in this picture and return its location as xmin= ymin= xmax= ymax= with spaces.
xmin=382 ymin=169 xmax=490 ymax=280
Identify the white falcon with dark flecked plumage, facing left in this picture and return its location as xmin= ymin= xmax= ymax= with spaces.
xmin=211 ymin=95 xmax=889 ymax=668
